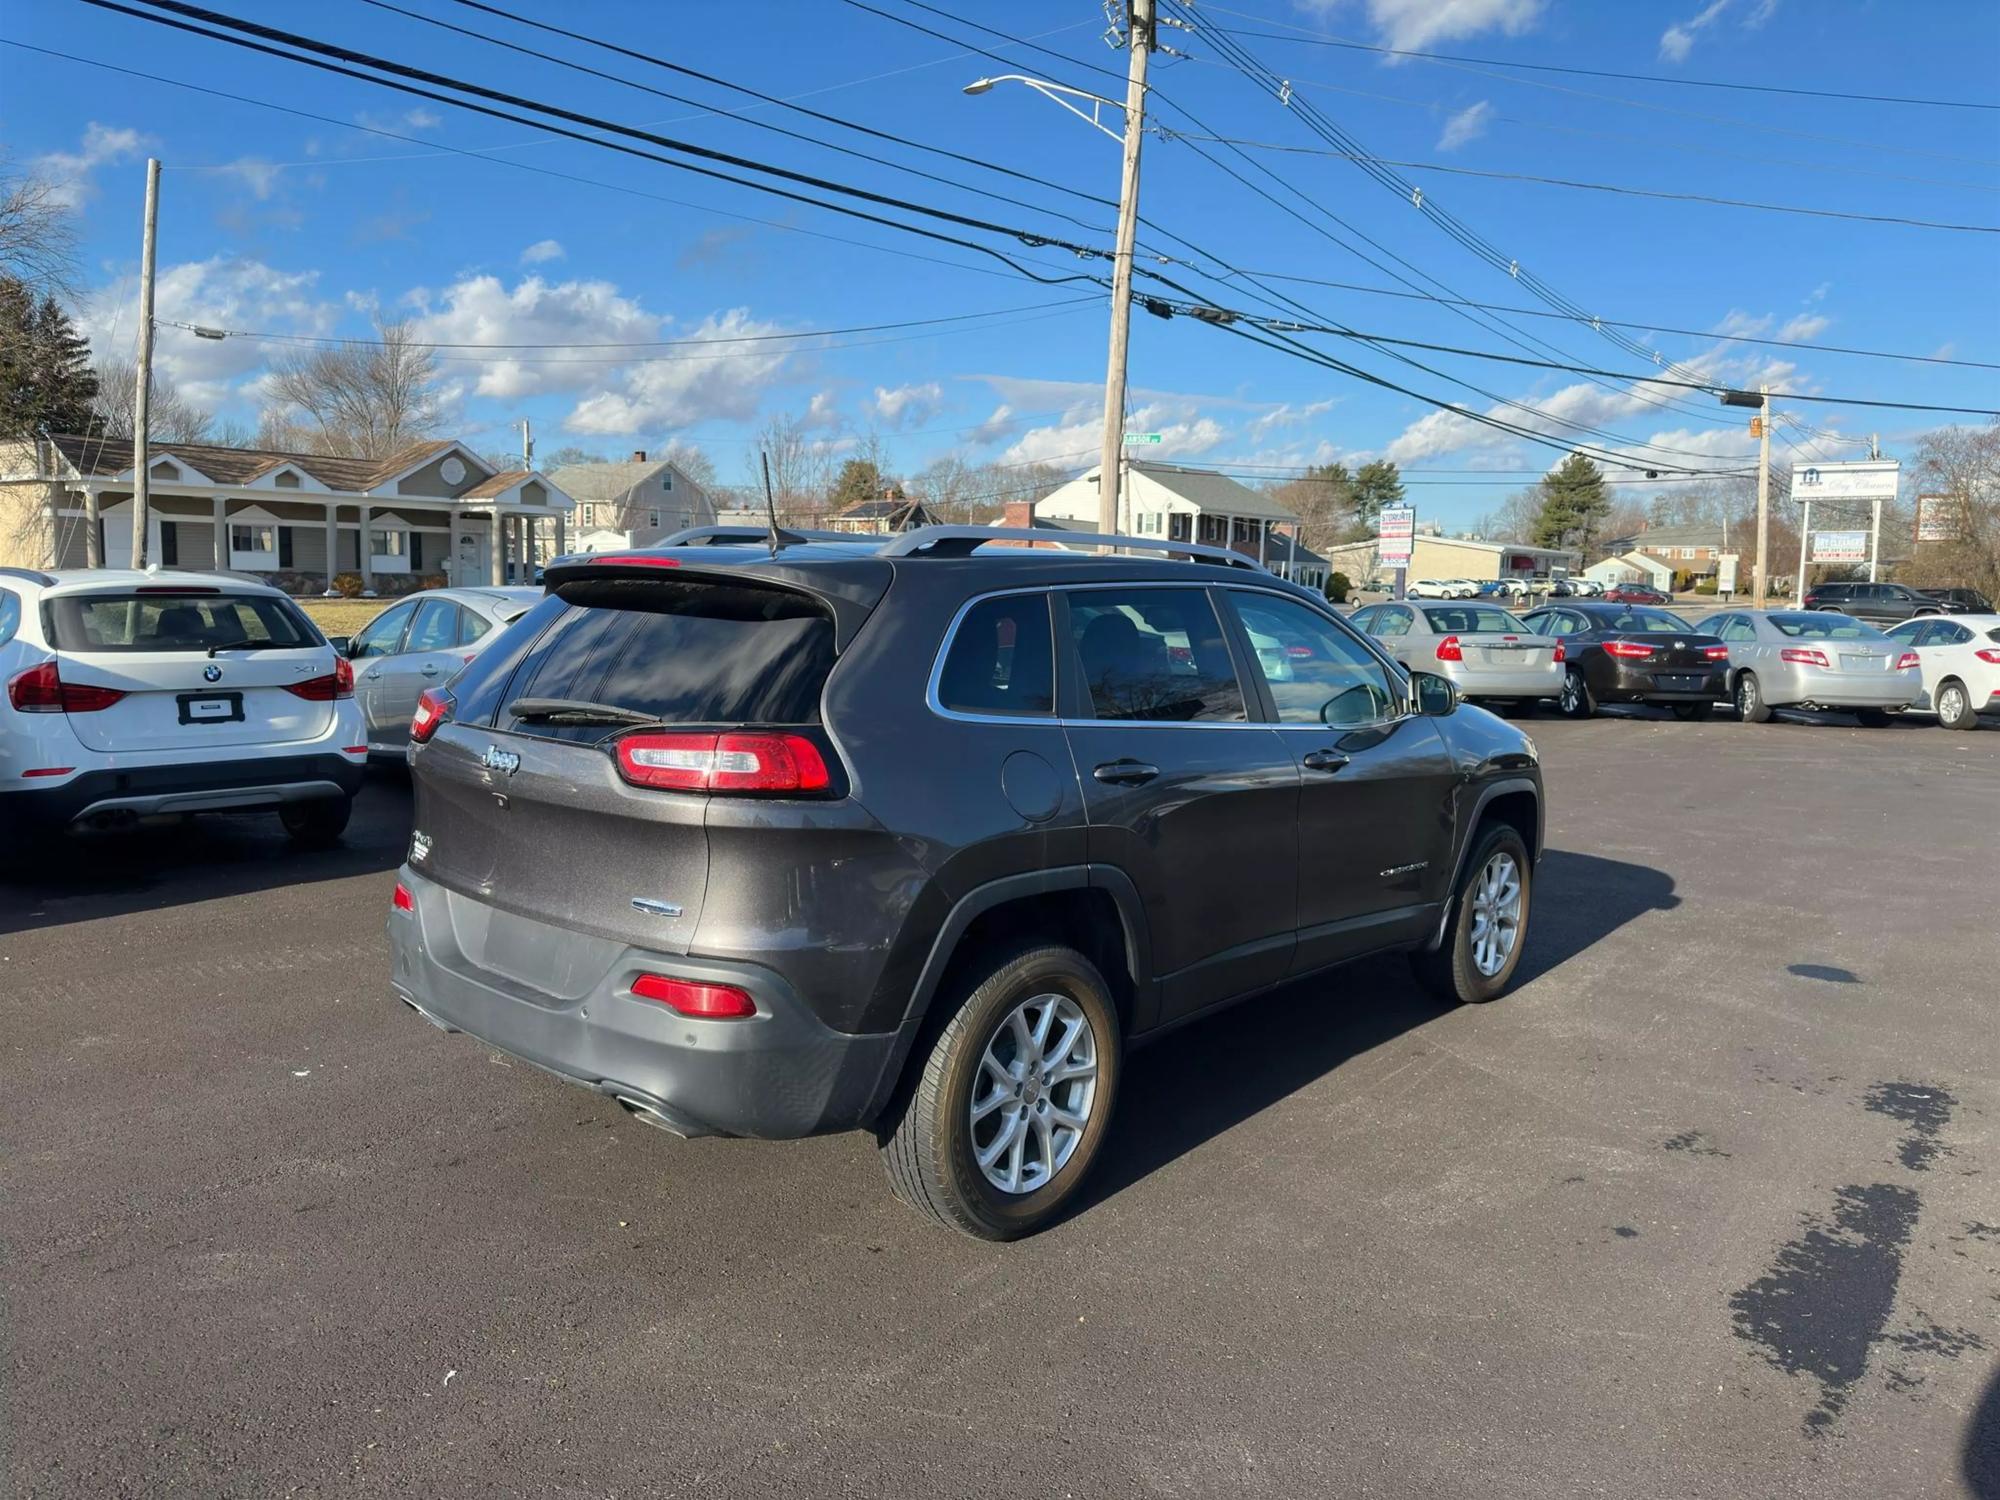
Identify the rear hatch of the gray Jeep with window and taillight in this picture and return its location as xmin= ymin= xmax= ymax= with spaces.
xmin=412 ymin=560 xmax=888 ymax=980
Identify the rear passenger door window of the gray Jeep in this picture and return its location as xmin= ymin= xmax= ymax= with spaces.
xmin=1070 ymin=588 xmax=1244 ymax=722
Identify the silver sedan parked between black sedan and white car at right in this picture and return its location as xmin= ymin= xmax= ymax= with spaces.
xmin=1704 ymin=610 xmax=1922 ymax=728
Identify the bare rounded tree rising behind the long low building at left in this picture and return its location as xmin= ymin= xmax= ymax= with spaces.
xmin=266 ymin=320 xmax=442 ymax=458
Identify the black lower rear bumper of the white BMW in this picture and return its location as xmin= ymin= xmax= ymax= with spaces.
xmin=0 ymin=754 xmax=366 ymax=828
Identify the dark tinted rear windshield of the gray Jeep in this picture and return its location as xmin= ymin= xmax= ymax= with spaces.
xmin=498 ymin=578 xmax=834 ymax=742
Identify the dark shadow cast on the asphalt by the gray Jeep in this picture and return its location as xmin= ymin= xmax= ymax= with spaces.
xmin=1066 ymin=850 xmax=1680 ymax=1218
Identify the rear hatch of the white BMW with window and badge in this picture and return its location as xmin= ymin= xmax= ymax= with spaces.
xmin=44 ymin=584 xmax=336 ymax=752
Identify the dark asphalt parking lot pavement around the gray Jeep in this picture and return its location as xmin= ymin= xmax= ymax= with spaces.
xmin=0 ymin=712 xmax=2000 ymax=1500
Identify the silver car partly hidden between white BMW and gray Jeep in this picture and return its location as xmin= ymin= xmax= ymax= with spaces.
xmin=334 ymin=588 xmax=542 ymax=760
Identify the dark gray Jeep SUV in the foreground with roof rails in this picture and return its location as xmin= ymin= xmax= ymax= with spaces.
xmin=390 ymin=528 xmax=1542 ymax=1238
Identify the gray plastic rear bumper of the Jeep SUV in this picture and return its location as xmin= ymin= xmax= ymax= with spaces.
xmin=388 ymin=866 xmax=896 ymax=1140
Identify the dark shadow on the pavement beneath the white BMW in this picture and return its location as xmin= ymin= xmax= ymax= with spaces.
xmin=0 ymin=774 xmax=410 ymax=934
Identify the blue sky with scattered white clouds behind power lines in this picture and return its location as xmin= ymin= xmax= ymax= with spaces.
xmin=0 ymin=0 xmax=2000 ymax=524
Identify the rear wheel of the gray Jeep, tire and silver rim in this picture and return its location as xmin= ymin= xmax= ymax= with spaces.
xmin=882 ymin=946 xmax=1122 ymax=1240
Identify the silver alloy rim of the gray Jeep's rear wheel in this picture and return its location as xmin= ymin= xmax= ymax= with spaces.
xmin=970 ymin=994 xmax=1098 ymax=1194
